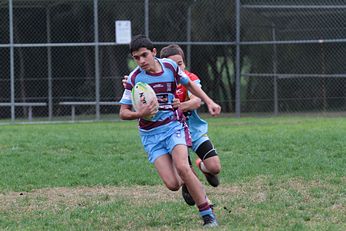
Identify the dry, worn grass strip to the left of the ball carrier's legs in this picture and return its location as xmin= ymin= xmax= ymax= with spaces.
xmin=0 ymin=186 xmax=180 ymax=211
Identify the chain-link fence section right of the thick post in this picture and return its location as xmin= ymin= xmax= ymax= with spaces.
xmin=241 ymin=0 xmax=346 ymax=114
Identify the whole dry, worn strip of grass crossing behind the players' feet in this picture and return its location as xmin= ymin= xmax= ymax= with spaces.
xmin=0 ymin=177 xmax=346 ymax=215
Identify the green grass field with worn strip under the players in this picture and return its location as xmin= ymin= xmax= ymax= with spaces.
xmin=0 ymin=117 xmax=346 ymax=230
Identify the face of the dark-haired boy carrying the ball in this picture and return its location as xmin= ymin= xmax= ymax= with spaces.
xmin=132 ymin=47 xmax=156 ymax=71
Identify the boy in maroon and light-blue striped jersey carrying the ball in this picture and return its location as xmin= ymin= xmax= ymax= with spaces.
xmin=119 ymin=35 xmax=221 ymax=227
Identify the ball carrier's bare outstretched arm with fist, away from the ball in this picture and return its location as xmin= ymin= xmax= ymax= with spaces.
xmin=185 ymin=80 xmax=221 ymax=116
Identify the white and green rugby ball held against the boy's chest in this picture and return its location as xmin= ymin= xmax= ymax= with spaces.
xmin=131 ymin=82 xmax=159 ymax=119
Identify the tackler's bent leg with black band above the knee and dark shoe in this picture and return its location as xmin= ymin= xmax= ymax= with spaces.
xmin=195 ymin=137 xmax=221 ymax=187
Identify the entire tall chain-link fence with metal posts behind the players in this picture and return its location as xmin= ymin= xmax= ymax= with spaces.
xmin=0 ymin=0 xmax=346 ymax=123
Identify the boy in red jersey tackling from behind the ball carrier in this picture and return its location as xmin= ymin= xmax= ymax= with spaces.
xmin=160 ymin=44 xmax=221 ymax=187
